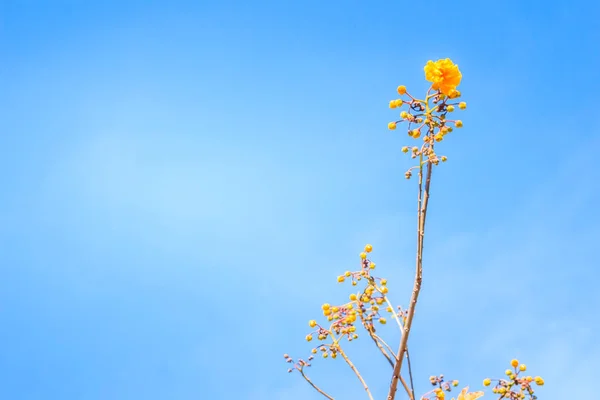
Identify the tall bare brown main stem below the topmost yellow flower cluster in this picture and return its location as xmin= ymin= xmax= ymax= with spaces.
xmin=387 ymin=161 xmax=432 ymax=400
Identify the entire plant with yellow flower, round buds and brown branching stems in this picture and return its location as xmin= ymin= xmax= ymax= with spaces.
xmin=284 ymin=58 xmax=544 ymax=400
